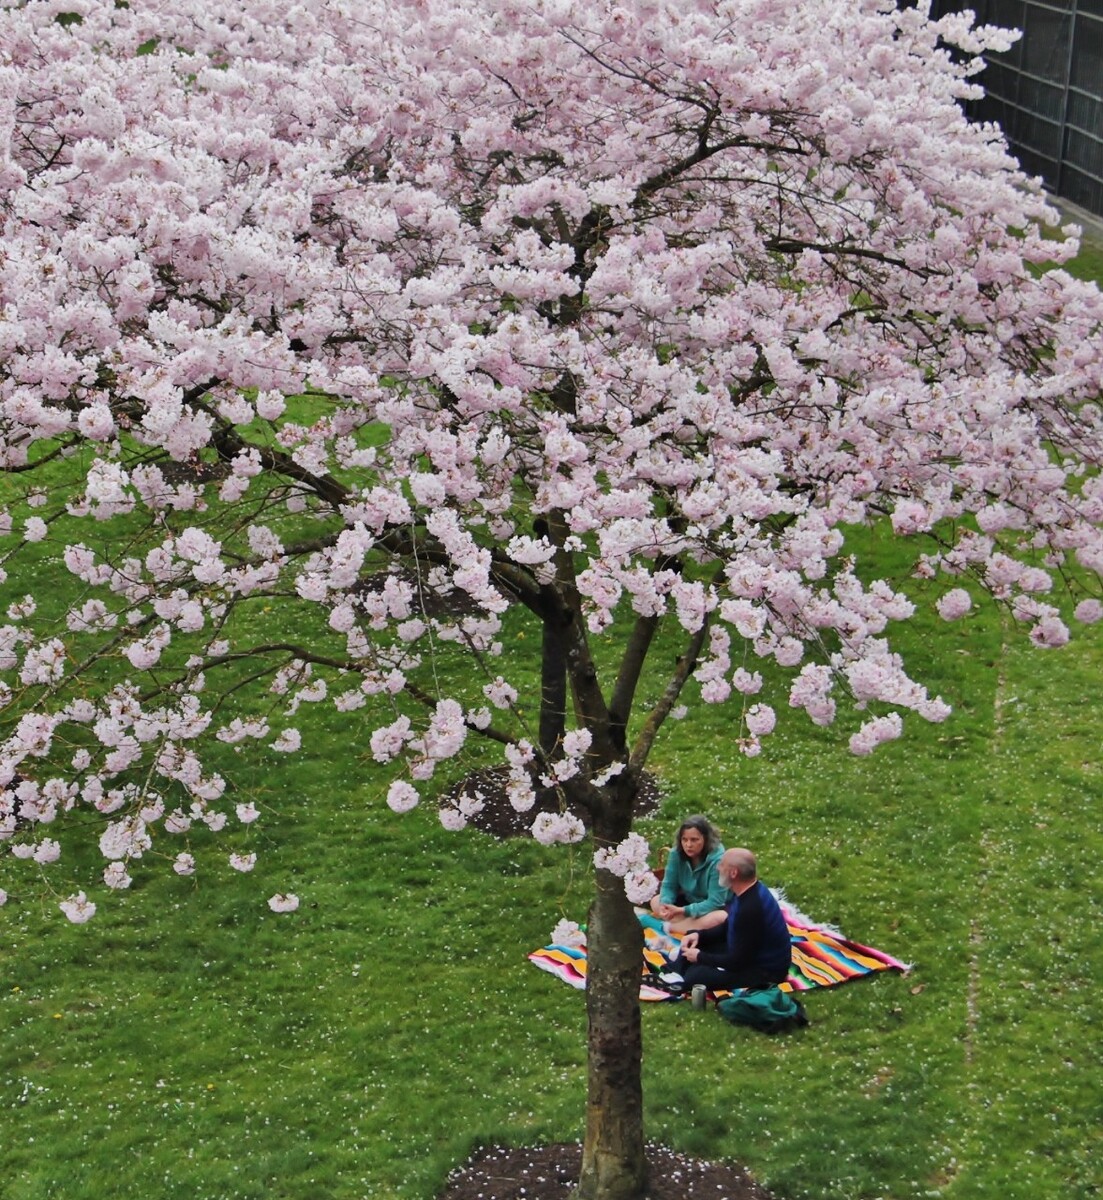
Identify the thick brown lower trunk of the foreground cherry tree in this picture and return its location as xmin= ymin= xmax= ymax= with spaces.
xmin=575 ymin=787 xmax=647 ymax=1200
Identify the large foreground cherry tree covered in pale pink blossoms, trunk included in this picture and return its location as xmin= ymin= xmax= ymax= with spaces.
xmin=0 ymin=0 xmax=1103 ymax=1200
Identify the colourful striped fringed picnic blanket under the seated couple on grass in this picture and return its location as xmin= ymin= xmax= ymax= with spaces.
xmin=528 ymin=895 xmax=909 ymax=1000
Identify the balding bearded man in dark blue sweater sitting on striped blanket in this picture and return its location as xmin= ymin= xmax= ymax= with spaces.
xmin=673 ymin=848 xmax=792 ymax=991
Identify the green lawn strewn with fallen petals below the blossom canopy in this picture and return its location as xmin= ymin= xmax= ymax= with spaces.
xmin=0 ymin=540 xmax=1103 ymax=1200
